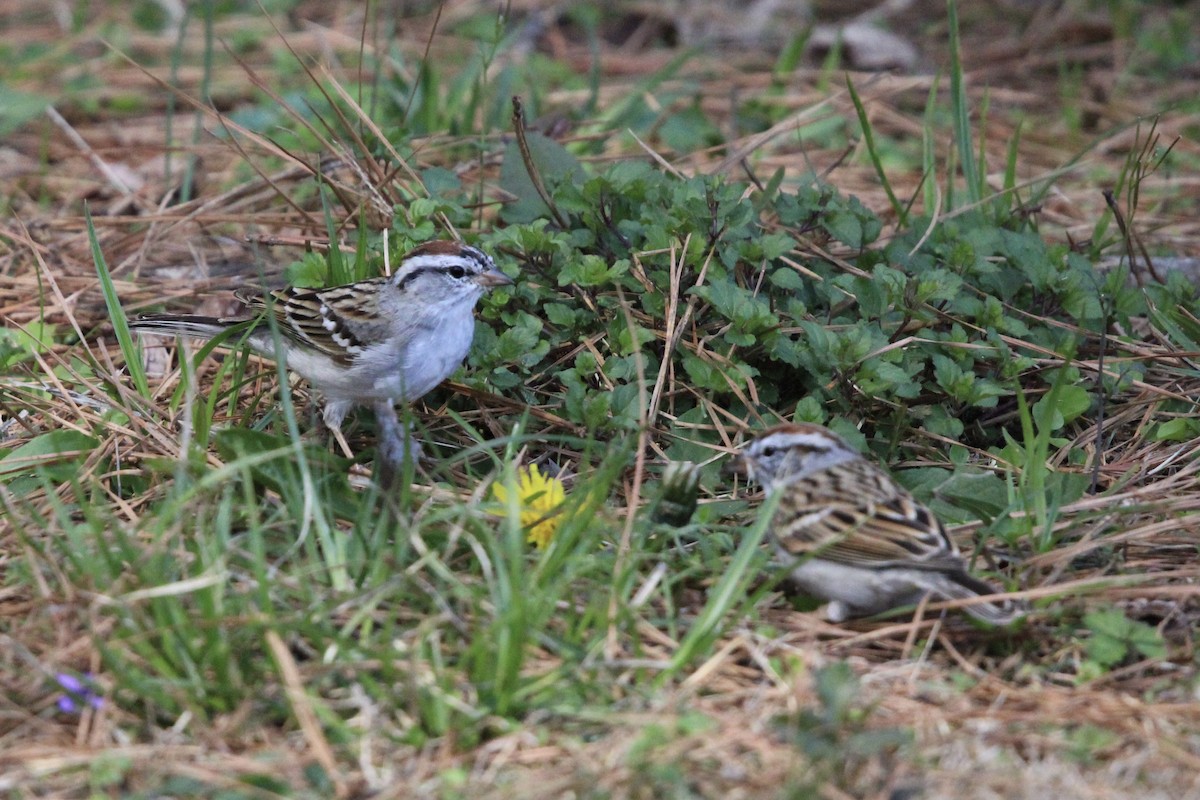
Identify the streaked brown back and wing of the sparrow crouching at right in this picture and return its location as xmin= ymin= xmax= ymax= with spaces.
xmin=774 ymin=461 xmax=961 ymax=569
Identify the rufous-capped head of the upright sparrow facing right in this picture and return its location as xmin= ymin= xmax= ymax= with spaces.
xmin=391 ymin=241 xmax=512 ymax=305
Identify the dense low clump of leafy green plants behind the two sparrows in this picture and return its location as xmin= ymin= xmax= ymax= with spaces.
xmin=473 ymin=136 xmax=1161 ymax=470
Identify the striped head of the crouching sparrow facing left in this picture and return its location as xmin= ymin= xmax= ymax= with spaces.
xmin=733 ymin=423 xmax=860 ymax=492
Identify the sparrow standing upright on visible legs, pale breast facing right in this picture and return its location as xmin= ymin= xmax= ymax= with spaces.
xmin=130 ymin=241 xmax=512 ymax=469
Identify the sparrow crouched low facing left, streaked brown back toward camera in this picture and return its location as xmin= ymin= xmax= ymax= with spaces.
xmin=734 ymin=425 xmax=1024 ymax=625
